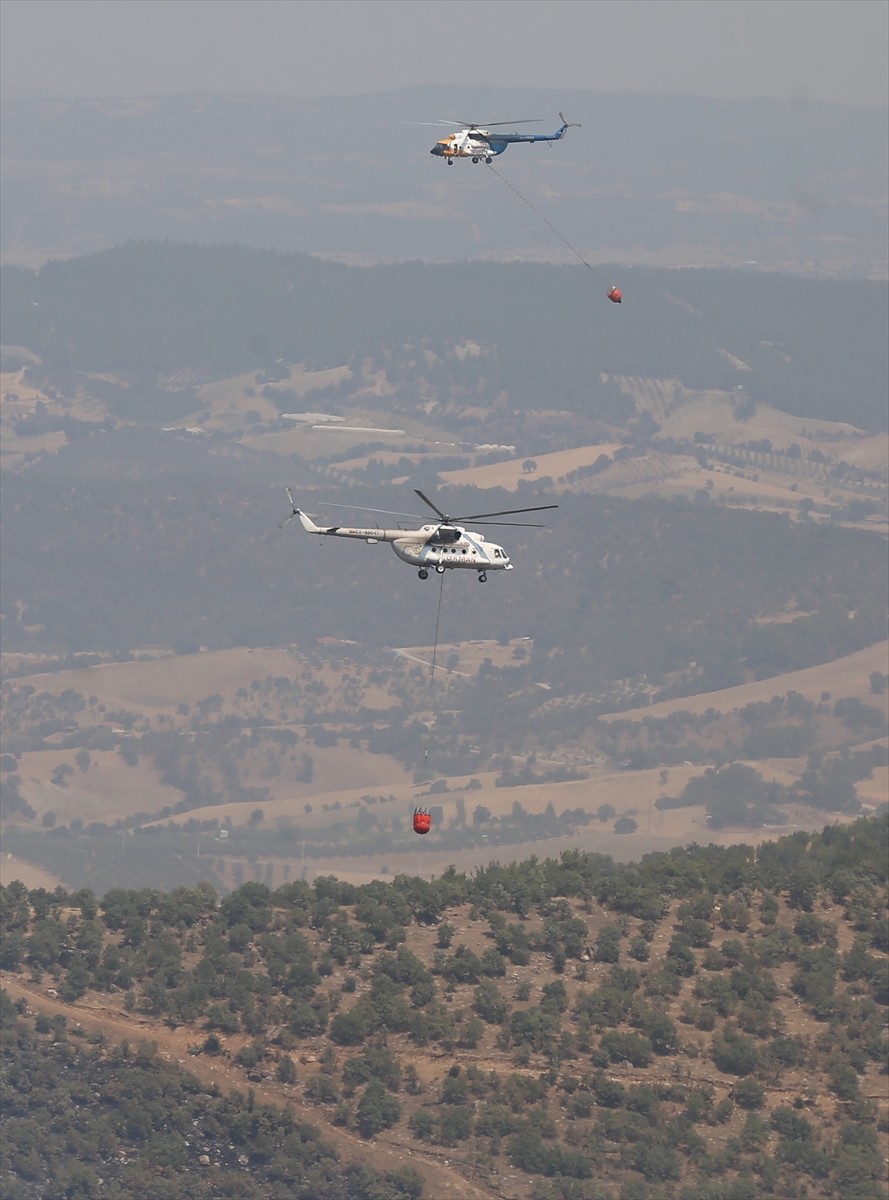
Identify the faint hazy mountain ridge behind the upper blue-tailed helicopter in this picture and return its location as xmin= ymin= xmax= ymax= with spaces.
xmin=0 ymin=86 xmax=889 ymax=278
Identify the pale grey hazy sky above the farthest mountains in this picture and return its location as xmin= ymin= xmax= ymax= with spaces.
xmin=0 ymin=0 xmax=889 ymax=104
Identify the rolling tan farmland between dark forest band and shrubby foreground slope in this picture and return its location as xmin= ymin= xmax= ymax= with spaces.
xmin=0 ymin=622 xmax=889 ymax=890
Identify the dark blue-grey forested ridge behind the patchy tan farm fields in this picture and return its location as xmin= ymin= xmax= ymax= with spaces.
xmin=2 ymin=242 xmax=889 ymax=431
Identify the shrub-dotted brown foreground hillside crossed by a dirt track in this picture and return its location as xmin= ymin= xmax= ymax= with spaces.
xmin=0 ymin=816 xmax=889 ymax=1200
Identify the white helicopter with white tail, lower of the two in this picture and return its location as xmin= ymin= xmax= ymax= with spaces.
xmin=280 ymin=487 xmax=559 ymax=583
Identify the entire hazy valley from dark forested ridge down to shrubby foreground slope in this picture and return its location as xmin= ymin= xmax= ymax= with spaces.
xmin=0 ymin=244 xmax=889 ymax=890
